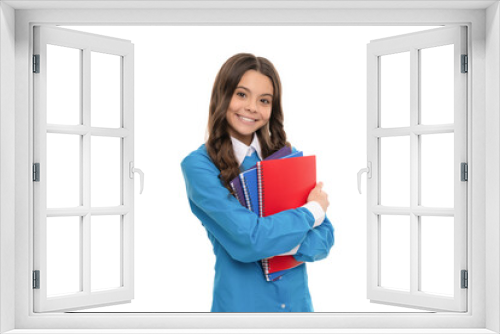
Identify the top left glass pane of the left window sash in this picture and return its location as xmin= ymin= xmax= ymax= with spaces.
xmin=47 ymin=44 xmax=81 ymax=125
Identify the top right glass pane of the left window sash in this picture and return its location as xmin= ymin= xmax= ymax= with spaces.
xmin=90 ymin=52 xmax=121 ymax=128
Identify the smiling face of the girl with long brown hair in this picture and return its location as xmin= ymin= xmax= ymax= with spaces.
xmin=226 ymin=70 xmax=274 ymax=145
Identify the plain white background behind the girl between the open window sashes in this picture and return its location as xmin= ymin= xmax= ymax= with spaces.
xmin=58 ymin=26 xmax=440 ymax=312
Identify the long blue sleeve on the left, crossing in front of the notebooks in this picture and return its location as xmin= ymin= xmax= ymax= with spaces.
xmin=181 ymin=154 xmax=315 ymax=262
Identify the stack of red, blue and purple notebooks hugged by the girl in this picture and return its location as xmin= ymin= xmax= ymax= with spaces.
xmin=230 ymin=146 xmax=316 ymax=281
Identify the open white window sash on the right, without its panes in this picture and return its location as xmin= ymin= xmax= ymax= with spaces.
xmin=367 ymin=26 xmax=468 ymax=312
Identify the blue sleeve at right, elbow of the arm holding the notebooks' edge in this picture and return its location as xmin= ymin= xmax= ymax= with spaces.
xmin=294 ymin=217 xmax=335 ymax=262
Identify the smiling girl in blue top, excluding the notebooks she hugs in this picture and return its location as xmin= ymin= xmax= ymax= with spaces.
xmin=181 ymin=54 xmax=334 ymax=312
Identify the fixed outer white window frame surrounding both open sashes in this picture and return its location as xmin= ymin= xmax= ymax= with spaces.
xmin=0 ymin=1 xmax=500 ymax=333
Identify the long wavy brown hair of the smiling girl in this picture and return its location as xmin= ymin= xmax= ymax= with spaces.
xmin=205 ymin=53 xmax=290 ymax=194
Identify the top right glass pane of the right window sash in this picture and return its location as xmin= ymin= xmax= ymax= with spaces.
xmin=420 ymin=45 xmax=455 ymax=124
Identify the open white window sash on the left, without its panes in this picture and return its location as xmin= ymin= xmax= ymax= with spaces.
xmin=33 ymin=26 xmax=134 ymax=312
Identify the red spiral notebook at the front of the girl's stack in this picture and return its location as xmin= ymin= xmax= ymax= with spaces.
xmin=257 ymin=156 xmax=316 ymax=280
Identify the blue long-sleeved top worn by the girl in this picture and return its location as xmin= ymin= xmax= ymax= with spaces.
xmin=181 ymin=145 xmax=334 ymax=312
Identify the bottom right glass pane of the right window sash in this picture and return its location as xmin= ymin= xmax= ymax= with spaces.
xmin=420 ymin=217 xmax=454 ymax=296
